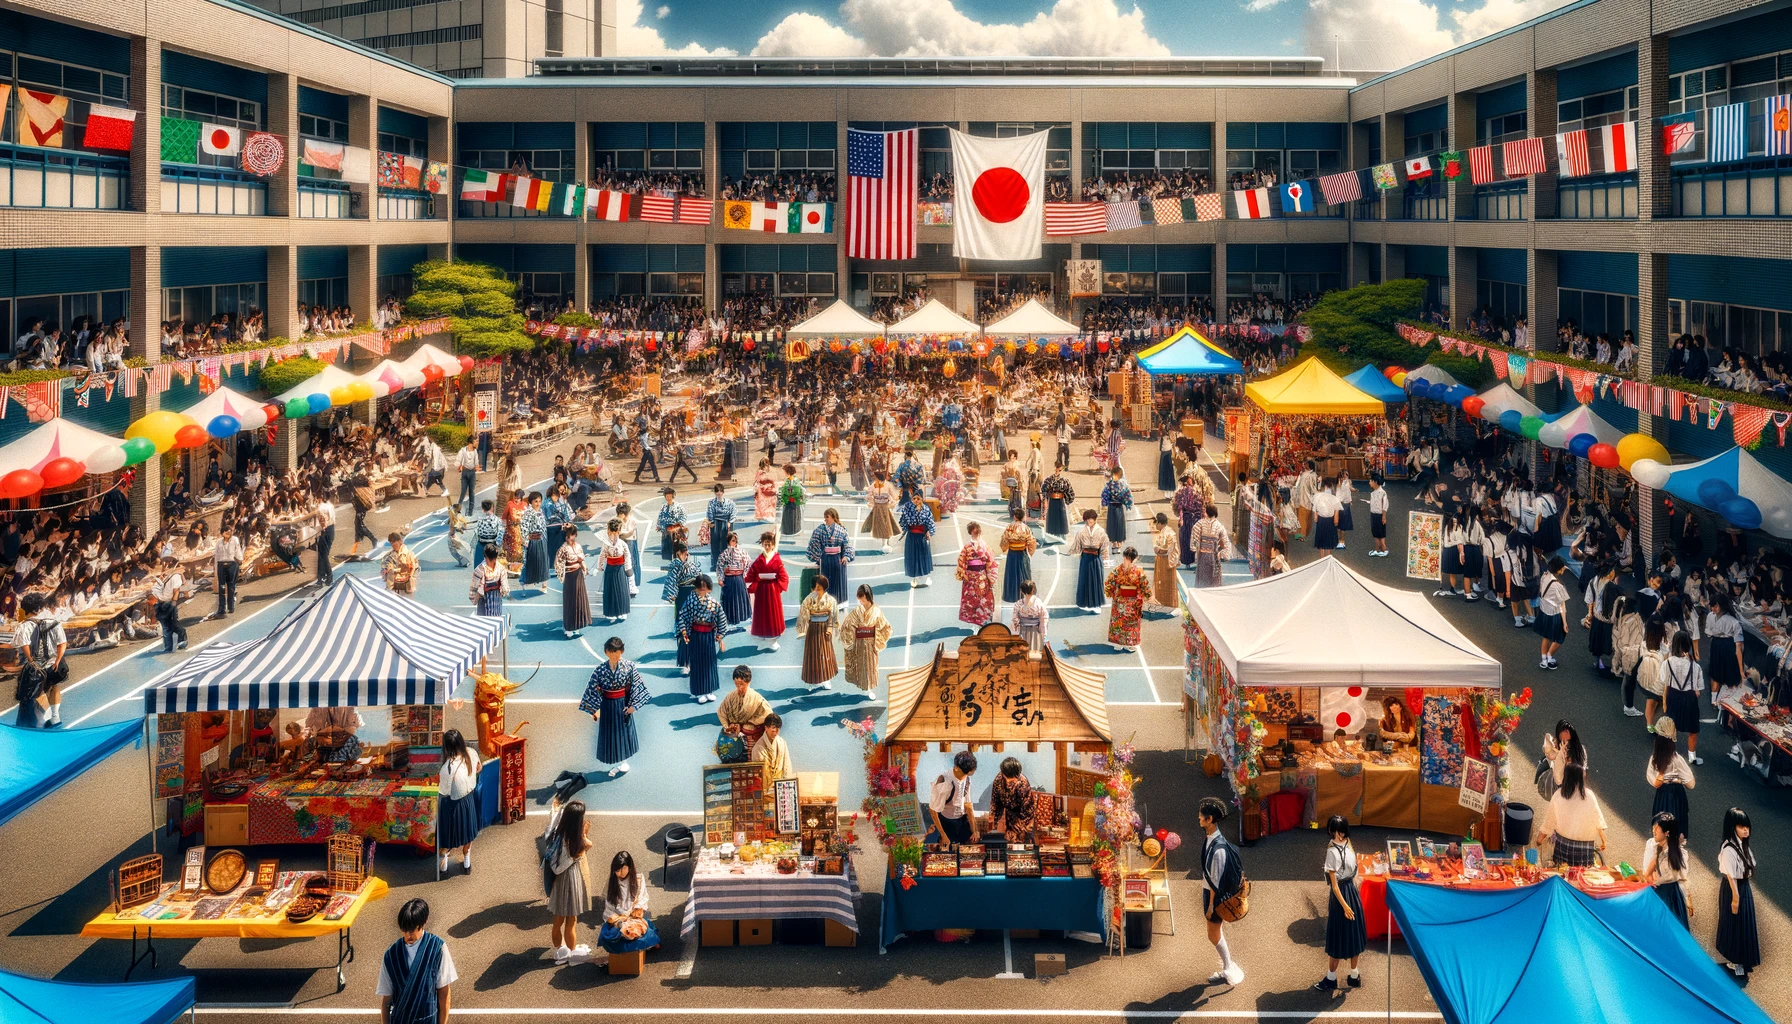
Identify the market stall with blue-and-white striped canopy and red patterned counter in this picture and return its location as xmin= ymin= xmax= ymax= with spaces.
xmin=143 ymin=576 xmax=504 ymax=848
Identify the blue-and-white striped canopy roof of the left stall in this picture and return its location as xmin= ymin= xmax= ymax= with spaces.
xmin=143 ymin=574 xmax=504 ymax=714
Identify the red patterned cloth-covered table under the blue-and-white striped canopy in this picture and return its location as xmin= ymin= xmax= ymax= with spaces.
xmin=249 ymin=778 xmax=435 ymax=850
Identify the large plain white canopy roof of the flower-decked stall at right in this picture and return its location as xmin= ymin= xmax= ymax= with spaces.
xmin=1188 ymin=558 xmax=1500 ymax=687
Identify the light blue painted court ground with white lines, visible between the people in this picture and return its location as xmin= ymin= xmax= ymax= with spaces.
xmin=42 ymin=482 xmax=1247 ymax=818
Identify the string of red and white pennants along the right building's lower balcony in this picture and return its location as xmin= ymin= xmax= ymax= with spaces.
xmin=1394 ymin=323 xmax=1792 ymax=448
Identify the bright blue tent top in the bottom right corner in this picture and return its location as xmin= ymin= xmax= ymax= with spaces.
xmin=1387 ymin=879 xmax=1770 ymax=1024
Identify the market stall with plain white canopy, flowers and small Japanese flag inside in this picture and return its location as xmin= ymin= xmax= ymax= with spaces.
xmin=1183 ymin=558 xmax=1529 ymax=846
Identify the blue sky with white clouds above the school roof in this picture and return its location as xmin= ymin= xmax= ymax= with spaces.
xmin=618 ymin=0 xmax=1566 ymax=70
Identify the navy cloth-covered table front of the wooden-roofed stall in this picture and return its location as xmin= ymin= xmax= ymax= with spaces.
xmin=878 ymin=875 xmax=1107 ymax=952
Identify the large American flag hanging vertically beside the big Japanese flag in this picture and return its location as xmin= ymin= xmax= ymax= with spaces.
xmin=846 ymin=127 xmax=921 ymax=260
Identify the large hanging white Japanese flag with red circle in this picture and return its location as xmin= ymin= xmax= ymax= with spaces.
xmin=952 ymin=129 xmax=1050 ymax=260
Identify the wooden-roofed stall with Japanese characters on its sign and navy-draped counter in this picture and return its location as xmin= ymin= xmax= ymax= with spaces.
xmin=866 ymin=624 xmax=1111 ymax=947
